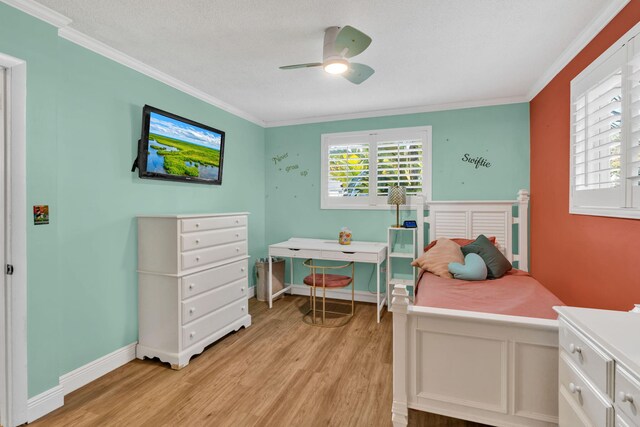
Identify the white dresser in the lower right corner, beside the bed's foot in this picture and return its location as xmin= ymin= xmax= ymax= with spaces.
xmin=555 ymin=307 xmax=640 ymax=427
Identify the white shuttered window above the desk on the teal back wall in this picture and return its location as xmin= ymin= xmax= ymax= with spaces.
xmin=321 ymin=126 xmax=431 ymax=209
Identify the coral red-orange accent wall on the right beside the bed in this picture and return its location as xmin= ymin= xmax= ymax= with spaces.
xmin=530 ymin=0 xmax=640 ymax=310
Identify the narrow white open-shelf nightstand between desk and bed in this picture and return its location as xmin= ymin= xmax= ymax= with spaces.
xmin=387 ymin=227 xmax=418 ymax=307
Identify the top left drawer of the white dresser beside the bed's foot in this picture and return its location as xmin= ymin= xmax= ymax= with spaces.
xmin=559 ymin=319 xmax=614 ymax=398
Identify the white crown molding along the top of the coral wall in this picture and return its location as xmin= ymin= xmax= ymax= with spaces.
xmin=527 ymin=0 xmax=630 ymax=100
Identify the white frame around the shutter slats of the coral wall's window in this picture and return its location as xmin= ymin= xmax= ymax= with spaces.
xmin=569 ymin=24 xmax=640 ymax=219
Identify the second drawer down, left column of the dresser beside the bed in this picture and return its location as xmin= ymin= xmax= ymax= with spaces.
xmin=559 ymin=352 xmax=613 ymax=427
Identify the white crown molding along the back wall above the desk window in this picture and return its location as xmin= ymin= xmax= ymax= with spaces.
xmin=265 ymin=96 xmax=529 ymax=128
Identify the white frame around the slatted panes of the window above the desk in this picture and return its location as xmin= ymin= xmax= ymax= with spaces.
xmin=320 ymin=126 xmax=433 ymax=210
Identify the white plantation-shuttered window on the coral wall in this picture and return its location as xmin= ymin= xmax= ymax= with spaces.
xmin=569 ymin=26 xmax=640 ymax=218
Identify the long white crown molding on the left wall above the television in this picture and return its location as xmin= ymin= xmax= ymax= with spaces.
xmin=58 ymin=27 xmax=264 ymax=127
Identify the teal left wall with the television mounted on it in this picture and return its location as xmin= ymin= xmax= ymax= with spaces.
xmin=0 ymin=3 xmax=265 ymax=396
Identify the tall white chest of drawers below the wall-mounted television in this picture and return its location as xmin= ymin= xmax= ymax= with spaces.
xmin=136 ymin=213 xmax=251 ymax=369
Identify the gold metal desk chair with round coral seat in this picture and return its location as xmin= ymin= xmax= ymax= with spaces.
xmin=302 ymin=259 xmax=355 ymax=328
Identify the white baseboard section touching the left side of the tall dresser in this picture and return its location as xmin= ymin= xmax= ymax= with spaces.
xmin=60 ymin=342 xmax=137 ymax=396
